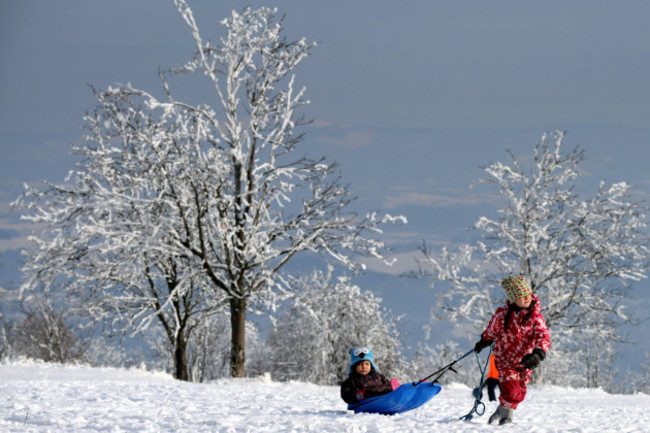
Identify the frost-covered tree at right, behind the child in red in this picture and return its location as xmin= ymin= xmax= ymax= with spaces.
xmin=414 ymin=131 xmax=648 ymax=385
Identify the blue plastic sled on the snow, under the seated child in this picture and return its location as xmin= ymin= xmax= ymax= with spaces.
xmin=348 ymin=382 xmax=442 ymax=415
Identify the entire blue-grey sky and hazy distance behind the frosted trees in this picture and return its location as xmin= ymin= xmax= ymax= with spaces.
xmin=0 ymin=0 xmax=650 ymax=368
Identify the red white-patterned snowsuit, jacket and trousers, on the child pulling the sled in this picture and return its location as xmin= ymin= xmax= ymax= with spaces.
xmin=481 ymin=294 xmax=551 ymax=409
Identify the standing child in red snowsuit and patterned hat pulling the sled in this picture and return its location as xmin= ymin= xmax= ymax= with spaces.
xmin=474 ymin=275 xmax=551 ymax=424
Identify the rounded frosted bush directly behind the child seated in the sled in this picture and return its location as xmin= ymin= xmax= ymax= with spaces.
xmin=267 ymin=267 xmax=402 ymax=385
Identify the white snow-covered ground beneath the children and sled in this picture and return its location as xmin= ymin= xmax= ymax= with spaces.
xmin=0 ymin=362 xmax=650 ymax=433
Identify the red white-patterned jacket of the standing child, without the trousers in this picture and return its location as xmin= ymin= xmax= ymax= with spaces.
xmin=481 ymin=294 xmax=551 ymax=370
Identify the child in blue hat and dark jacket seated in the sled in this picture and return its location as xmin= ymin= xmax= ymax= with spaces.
xmin=341 ymin=347 xmax=400 ymax=404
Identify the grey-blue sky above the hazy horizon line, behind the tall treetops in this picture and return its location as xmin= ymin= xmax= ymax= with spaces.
xmin=5 ymin=0 xmax=650 ymax=133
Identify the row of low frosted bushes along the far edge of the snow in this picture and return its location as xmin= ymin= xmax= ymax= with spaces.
xmin=0 ymin=269 xmax=650 ymax=392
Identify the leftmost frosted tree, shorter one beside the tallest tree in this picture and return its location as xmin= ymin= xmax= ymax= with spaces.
xmin=19 ymin=157 xmax=224 ymax=380
